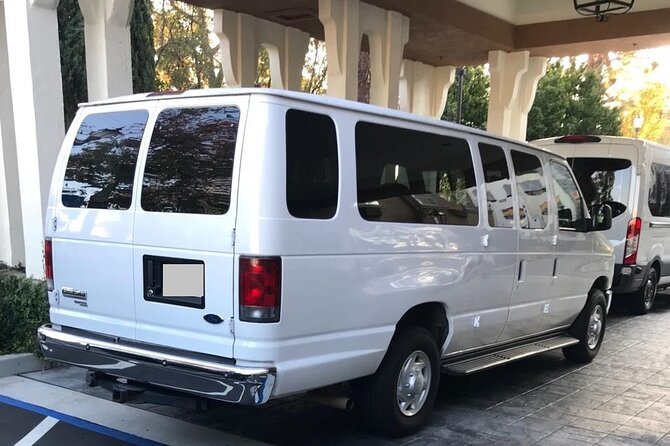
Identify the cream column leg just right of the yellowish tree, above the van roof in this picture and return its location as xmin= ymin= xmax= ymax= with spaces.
xmin=214 ymin=9 xmax=259 ymax=87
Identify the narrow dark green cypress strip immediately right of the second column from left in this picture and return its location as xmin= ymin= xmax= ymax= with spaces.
xmin=130 ymin=0 xmax=156 ymax=93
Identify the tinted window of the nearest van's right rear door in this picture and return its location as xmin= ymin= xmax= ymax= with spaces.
xmin=142 ymin=107 xmax=240 ymax=214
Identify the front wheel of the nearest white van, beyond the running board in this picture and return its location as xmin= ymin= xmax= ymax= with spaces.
xmin=563 ymin=288 xmax=607 ymax=364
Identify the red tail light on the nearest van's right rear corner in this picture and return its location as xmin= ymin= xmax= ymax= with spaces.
xmin=240 ymin=257 xmax=281 ymax=322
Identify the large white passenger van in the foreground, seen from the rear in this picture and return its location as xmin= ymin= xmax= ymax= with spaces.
xmin=39 ymin=89 xmax=614 ymax=435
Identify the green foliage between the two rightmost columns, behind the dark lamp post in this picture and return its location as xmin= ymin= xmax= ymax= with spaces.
xmin=442 ymin=66 xmax=489 ymax=129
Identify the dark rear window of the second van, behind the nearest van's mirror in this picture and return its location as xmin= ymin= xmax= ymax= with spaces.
xmin=568 ymin=158 xmax=632 ymax=217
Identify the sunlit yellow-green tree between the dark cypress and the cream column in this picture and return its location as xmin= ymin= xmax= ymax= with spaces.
xmin=153 ymin=0 xmax=223 ymax=90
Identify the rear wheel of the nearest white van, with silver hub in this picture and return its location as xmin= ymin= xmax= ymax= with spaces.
xmin=353 ymin=327 xmax=440 ymax=437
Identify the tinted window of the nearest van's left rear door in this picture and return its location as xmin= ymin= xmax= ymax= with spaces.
xmin=61 ymin=110 xmax=149 ymax=210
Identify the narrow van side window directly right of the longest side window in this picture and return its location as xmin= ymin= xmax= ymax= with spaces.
xmin=479 ymin=142 xmax=514 ymax=228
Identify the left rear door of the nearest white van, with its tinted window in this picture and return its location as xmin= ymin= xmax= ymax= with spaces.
xmin=46 ymin=104 xmax=149 ymax=339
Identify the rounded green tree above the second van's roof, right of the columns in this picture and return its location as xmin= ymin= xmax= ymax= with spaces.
xmin=526 ymin=60 xmax=620 ymax=141
